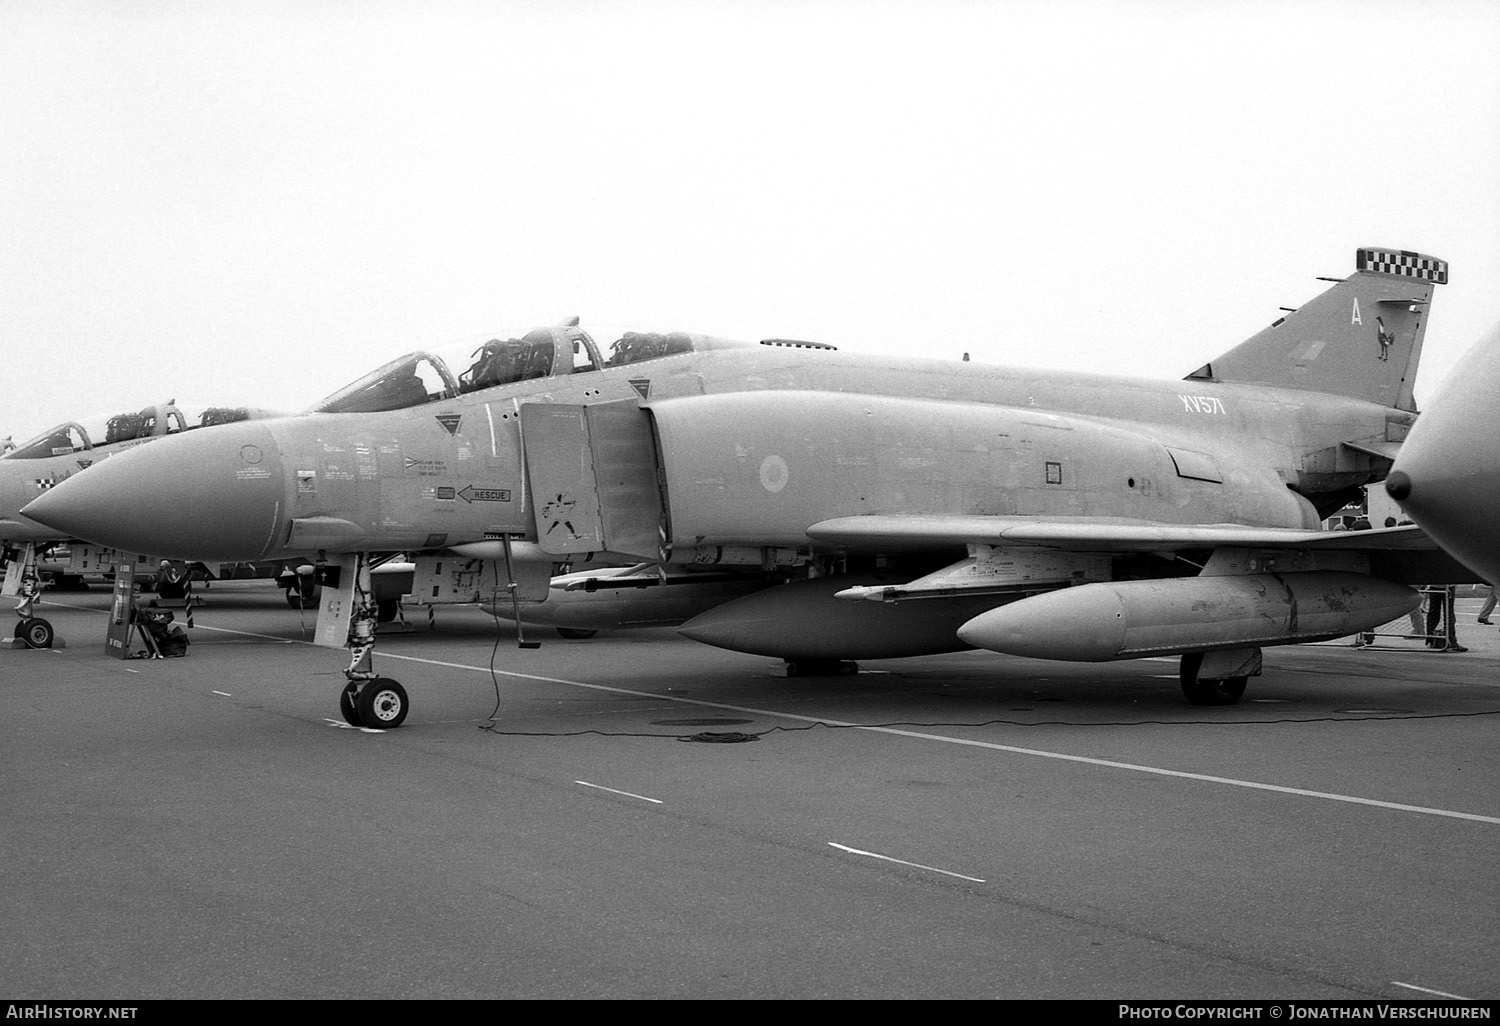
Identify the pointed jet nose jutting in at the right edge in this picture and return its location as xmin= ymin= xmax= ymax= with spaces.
xmin=1386 ymin=327 xmax=1500 ymax=582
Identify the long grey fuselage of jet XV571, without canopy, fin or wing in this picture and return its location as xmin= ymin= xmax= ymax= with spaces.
xmin=23 ymin=336 xmax=1413 ymax=560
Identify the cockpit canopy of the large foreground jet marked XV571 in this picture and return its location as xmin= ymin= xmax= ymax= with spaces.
xmin=312 ymin=318 xmax=726 ymax=413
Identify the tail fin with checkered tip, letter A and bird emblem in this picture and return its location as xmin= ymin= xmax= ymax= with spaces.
xmin=1188 ymin=249 xmax=1448 ymax=411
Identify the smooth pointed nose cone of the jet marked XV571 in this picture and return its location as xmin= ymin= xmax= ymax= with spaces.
xmin=23 ymin=423 xmax=285 ymax=560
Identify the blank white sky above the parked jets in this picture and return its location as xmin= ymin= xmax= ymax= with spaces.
xmin=0 ymin=0 xmax=1500 ymax=441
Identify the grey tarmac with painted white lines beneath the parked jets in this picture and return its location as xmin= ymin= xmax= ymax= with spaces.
xmin=0 ymin=582 xmax=1500 ymax=1001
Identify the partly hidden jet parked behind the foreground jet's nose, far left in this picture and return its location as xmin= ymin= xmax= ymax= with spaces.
xmin=0 ymin=401 xmax=270 ymax=648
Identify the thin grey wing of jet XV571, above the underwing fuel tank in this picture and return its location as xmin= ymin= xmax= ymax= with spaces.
xmin=807 ymin=515 xmax=1439 ymax=552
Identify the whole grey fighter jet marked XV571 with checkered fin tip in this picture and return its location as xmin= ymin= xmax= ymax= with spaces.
xmin=26 ymin=248 xmax=1472 ymax=728
